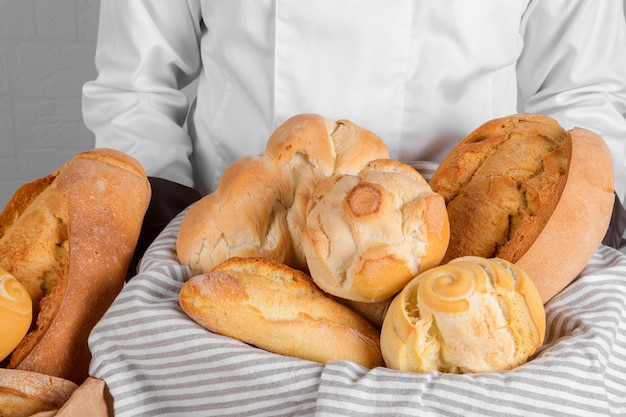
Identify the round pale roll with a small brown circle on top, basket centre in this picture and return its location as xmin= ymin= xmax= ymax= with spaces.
xmin=302 ymin=159 xmax=450 ymax=303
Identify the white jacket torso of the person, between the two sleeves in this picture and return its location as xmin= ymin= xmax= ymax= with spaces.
xmin=189 ymin=0 xmax=528 ymax=191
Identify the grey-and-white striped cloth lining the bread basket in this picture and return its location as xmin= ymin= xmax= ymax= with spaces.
xmin=89 ymin=208 xmax=626 ymax=417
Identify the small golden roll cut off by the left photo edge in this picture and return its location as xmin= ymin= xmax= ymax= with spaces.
xmin=0 ymin=267 xmax=33 ymax=362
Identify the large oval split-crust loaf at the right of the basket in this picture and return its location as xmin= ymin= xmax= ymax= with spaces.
xmin=430 ymin=114 xmax=614 ymax=303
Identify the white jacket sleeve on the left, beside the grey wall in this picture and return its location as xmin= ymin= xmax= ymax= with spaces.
xmin=83 ymin=0 xmax=201 ymax=186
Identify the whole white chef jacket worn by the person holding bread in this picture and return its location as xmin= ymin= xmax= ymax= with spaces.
xmin=83 ymin=0 xmax=626 ymax=200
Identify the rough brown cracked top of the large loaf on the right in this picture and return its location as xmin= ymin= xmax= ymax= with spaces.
xmin=430 ymin=115 xmax=571 ymax=263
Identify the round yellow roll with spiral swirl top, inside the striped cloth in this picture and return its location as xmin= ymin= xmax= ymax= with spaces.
xmin=381 ymin=256 xmax=546 ymax=373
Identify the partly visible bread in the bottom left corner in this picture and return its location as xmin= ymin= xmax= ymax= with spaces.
xmin=0 ymin=369 xmax=77 ymax=417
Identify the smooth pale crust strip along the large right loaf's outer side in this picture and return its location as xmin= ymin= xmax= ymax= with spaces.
xmin=516 ymin=128 xmax=615 ymax=302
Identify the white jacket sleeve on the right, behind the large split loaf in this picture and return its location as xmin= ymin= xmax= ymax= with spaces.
xmin=517 ymin=0 xmax=626 ymax=201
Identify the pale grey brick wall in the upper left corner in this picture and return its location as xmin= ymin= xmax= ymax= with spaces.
xmin=0 ymin=0 xmax=99 ymax=210
